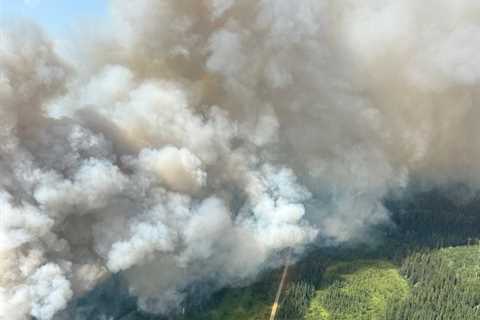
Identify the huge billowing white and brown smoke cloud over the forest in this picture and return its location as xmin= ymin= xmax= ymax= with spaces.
xmin=0 ymin=0 xmax=480 ymax=320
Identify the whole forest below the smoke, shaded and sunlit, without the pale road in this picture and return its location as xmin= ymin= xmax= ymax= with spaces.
xmin=174 ymin=191 xmax=480 ymax=320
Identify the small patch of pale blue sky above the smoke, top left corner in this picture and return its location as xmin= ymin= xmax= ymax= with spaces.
xmin=0 ymin=0 xmax=107 ymax=35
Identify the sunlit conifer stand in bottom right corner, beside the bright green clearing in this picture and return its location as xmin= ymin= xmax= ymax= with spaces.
xmin=388 ymin=246 xmax=480 ymax=320
